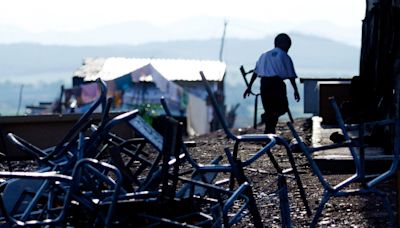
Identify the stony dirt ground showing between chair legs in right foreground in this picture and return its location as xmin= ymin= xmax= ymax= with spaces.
xmin=187 ymin=119 xmax=396 ymax=227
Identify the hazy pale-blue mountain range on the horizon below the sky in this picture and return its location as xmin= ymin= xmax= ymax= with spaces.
xmin=0 ymin=34 xmax=359 ymax=77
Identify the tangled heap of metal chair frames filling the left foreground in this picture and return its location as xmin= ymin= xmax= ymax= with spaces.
xmin=0 ymin=77 xmax=268 ymax=227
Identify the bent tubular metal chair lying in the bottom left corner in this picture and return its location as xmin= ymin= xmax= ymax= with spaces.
xmin=0 ymin=159 xmax=122 ymax=227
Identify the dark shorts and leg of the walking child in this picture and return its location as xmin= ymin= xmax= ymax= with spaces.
xmin=260 ymin=77 xmax=288 ymax=134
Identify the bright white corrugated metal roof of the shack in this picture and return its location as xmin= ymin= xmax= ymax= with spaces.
xmin=74 ymin=57 xmax=226 ymax=81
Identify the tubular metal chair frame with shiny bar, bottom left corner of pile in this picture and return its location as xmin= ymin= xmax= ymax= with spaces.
xmin=0 ymin=159 xmax=122 ymax=227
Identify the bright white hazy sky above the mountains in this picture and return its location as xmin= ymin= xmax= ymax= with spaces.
xmin=0 ymin=0 xmax=365 ymax=46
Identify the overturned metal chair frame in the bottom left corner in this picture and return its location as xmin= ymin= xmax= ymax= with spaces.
xmin=0 ymin=159 xmax=122 ymax=227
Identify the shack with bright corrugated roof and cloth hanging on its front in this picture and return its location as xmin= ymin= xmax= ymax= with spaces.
xmin=66 ymin=57 xmax=226 ymax=134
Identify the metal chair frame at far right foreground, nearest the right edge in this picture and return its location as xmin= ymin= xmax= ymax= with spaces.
xmin=287 ymin=98 xmax=400 ymax=227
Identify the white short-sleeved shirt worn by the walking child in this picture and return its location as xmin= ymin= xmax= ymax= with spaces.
xmin=254 ymin=47 xmax=297 ymax=79
